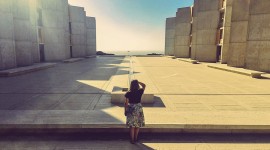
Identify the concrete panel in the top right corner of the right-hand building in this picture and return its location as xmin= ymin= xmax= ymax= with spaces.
xmin=250 ymin=0 xmax=270 ymax=15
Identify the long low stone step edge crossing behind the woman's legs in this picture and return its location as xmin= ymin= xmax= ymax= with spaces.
xmin=0 ymin=124 xmax=270 ymax=134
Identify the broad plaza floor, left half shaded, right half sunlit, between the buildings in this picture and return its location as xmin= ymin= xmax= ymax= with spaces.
xmin=0 ymin=57 xmax=270 ymax=132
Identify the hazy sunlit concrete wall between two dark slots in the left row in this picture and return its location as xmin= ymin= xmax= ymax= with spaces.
xmin=38 ymin=0 xmax=70 ymax=61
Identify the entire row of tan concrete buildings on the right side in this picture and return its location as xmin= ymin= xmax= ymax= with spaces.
xmin=165 ymin=0 xmax=270 ymax=72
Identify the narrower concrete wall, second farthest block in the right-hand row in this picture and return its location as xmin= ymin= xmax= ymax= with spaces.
xmin=174 ymin=7 xmax=192 ymax=58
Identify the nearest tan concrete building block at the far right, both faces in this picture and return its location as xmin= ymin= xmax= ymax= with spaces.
xmin=228 ymin=0 xmax=270 ymax=72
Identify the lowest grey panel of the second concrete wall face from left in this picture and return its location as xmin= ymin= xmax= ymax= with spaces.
xmin=15 ymin=41 xmax=33 ymax=66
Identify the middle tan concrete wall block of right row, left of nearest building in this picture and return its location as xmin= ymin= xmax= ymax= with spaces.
xmin=192 ymin=0 xmax=219 ymax=62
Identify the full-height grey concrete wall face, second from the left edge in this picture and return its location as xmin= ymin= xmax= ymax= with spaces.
xmin=13 ymin=0 xmax=33 ymax=66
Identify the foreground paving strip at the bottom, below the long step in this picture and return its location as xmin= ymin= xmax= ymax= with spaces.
xmin=0 ymin=134 xmax=270 ymax=150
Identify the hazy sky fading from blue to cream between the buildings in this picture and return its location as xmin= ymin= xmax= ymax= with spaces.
xmin=69 ymin=0 xmax=193 ymax=51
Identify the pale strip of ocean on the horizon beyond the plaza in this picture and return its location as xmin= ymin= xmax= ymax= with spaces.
xmin=103 ymin=50 xmax=164 ymax=55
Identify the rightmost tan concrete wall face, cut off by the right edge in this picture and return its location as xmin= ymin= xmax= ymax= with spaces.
xmin=246 ymin=0 xmax=270 ymax=72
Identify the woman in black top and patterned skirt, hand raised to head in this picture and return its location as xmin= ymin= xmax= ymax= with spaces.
xmin=125 ymin=80 xmax=146 ymax=144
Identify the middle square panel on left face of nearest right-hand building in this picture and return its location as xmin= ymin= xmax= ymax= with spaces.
xmin=230 ymin=21 xmax=248 ymax=43
